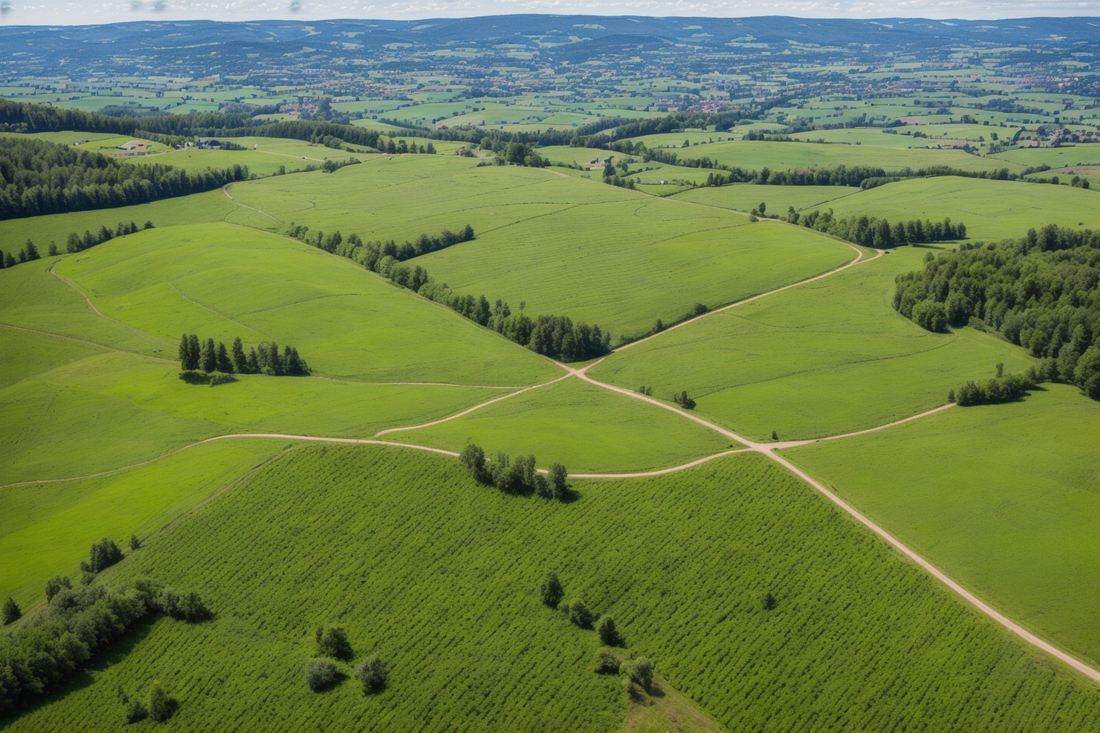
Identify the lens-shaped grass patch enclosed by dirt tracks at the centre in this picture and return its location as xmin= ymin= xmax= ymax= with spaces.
xmin=383 ymin=378 xmax=740 ymax=473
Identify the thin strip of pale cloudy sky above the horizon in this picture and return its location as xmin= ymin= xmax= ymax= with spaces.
xmin=0 ymin=0 xmax=1100 ymax=25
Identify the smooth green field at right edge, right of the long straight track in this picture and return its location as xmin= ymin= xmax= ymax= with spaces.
xmin=789 ymin=385 xmax=1100 ymax=665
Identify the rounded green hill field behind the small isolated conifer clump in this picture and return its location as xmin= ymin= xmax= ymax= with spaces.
xmin=57 ymin=225 xmax=560 ymax=386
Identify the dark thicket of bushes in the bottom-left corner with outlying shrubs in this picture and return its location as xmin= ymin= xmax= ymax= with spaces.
xmin=0 ymin=539 xmax=210 ymax=722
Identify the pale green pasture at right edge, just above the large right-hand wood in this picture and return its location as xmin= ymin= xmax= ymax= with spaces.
xmin=820 ymin=176 xmax=1100 ymax=241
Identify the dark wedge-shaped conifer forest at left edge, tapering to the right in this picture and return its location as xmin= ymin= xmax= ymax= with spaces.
xmin=0 ymin=138 xmax=249 ymax=219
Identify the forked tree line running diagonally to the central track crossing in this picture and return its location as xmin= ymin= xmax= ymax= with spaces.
xmin=287 ymin=222 xmax=612 ymax=361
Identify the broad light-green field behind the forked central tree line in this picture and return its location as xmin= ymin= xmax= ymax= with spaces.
xmin=230 ymin=156 xmax=851 ymax=337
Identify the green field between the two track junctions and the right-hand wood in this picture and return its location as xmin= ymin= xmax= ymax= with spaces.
xmin=590 ymin=248 xmax=1032 ymax=440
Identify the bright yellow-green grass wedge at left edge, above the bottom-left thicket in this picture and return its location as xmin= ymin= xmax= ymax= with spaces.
xmin=0 ymin=439 xmax=289 ymax=609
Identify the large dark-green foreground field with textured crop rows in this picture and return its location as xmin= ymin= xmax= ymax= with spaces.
xmin=10 ymin=447 xmax=1100 ymax=732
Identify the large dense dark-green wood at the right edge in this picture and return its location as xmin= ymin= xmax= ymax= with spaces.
xmin=893 ymin=225 xmax=1100 ymax=400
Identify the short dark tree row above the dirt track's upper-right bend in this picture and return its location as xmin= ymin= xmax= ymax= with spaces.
xmin=787 ymin=204 xmax=967 ymax=250
